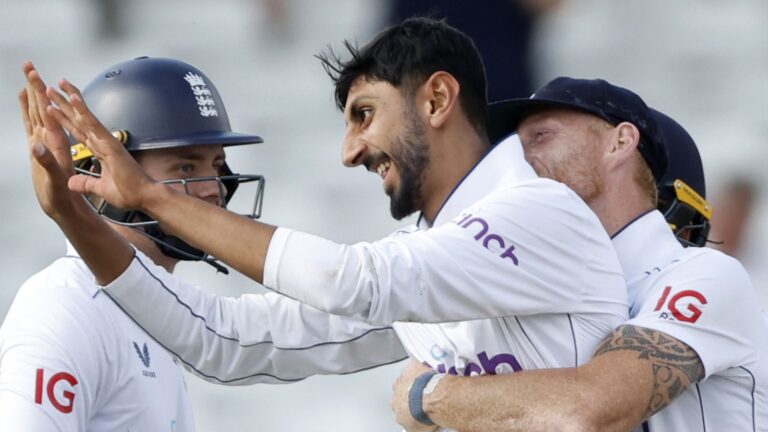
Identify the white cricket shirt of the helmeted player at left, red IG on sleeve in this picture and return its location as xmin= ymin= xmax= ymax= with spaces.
xmin=0 ymin=245 xmax=194 ymax=432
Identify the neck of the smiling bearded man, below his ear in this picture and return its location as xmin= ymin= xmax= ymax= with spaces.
xmin=421 ymin=123 xmax=489 ymax=225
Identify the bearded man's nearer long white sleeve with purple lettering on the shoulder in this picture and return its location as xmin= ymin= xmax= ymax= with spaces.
xmin=265 ymin=182 xmax=627 ymax=325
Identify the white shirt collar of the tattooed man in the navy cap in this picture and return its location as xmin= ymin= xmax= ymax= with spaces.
xmin=612 ymin=210 xmax=683 ymax=285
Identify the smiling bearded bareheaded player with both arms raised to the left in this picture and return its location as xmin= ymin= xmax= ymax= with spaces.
xmin=36 ymin=19 xmax=632 ymax=430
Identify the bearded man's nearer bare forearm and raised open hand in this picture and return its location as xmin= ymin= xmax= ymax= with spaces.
xmin=46 ymin=80 xmax=275 ymax=284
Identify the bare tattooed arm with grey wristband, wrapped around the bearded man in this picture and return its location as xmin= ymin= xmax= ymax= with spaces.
xmin=392 ymin=325 xmax=704 ymax=432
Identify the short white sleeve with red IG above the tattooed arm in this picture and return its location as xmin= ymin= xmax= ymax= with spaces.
xmin=627 ymin=250 xmax=764 ymax=377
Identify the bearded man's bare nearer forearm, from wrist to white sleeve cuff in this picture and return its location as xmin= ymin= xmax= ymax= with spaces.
xmin=142 ymin=183 xmax=275 ymax=282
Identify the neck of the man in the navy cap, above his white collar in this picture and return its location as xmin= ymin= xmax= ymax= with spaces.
xmin=587 ymin=182 xmax=654 ymax=237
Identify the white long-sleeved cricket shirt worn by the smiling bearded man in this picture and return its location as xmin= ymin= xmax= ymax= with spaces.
xmin=105 ymin=136 xmax=629 ymax=432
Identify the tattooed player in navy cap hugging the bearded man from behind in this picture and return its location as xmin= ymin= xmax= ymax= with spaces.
xmin=393 ymin=78 xmax=768 ymax=432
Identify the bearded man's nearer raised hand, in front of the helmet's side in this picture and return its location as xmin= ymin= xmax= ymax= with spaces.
xmin=46 ymin=80 xmax=157 ymax=213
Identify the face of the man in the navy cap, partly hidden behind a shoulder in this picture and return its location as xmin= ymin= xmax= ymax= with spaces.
xmin=518 ymin=109 xmax=608 ymax=203
